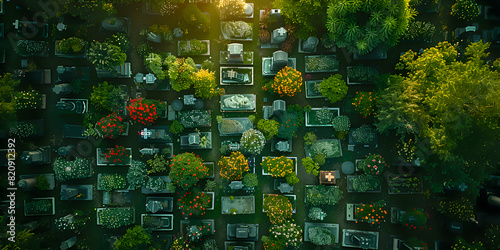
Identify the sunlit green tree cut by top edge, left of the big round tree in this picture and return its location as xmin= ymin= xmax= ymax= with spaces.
xmin=273 ymin=0 xmax=331 ymax=39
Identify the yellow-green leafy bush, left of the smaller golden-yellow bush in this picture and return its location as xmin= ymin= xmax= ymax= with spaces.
xmin=165 ymin=55 xmax=198 ymax=92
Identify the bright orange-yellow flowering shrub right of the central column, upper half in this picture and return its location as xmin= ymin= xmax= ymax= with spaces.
xmin=262 ymin=66 xmax=302 ymax=96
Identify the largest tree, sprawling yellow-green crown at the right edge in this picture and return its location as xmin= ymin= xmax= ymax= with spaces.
xmin=388 ymin=42 xmax=500 ymax=194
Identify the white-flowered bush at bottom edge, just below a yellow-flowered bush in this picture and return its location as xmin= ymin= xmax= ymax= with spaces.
xmin=269 ymin=220 xmax=303 ymax=249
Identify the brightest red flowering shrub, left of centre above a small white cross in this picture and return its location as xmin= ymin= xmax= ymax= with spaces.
xmin=127 ymin=98 xmax=163 ymax=125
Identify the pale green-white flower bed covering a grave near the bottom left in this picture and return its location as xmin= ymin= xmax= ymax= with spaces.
xmin=98 ymin=207 xmax=134 ymax=229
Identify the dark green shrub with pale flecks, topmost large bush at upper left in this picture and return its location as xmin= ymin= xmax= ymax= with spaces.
xmin=87 ymin=41 xmax=127 ymax=71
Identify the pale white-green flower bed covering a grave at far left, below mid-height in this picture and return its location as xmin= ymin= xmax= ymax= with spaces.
xmin=54 ymin=157 xmax=90 ymax=181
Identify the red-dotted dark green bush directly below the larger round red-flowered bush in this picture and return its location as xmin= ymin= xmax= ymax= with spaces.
xmin=177 ymin=191 xmax=212 ymax=217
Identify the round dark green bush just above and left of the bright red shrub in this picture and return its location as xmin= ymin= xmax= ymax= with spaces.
xmin=90 ymin=81 xmax=123 ymax=112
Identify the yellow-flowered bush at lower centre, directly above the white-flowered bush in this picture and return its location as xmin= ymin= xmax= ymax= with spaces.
xmin=263 ymin=194 xmax=293 ymax=224
